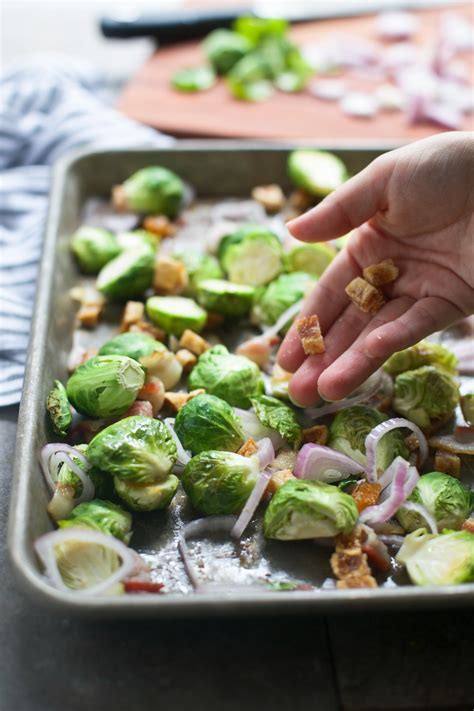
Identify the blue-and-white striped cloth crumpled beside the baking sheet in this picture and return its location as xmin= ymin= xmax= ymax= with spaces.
xmin=0 ymin=57 xmax=172 ymax=406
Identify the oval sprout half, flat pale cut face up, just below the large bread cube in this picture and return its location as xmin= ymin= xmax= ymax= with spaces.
xmin=146 ymin=296 xmax=207 ymax=336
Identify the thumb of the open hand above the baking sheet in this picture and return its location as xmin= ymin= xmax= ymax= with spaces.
xmin=287 ymin=154 xmax=395 ymax=242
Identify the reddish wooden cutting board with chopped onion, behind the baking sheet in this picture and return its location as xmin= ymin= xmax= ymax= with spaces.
xmin=118 ymin=3 xmax=474 ymax=142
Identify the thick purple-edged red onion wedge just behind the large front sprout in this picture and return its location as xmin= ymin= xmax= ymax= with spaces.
xmin=293 ymin=442 xmax=364 ymax=483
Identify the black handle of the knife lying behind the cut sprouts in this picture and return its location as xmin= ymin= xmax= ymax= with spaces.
xmin=100 ymin=7 xmax=251 ymax=45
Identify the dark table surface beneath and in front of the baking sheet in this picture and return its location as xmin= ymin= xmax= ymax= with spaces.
xmin=0 ymin=407 xmax=474 ymax=711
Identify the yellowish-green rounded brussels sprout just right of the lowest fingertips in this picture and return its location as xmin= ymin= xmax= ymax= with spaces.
xmin=392 ymin=365 xmax=459 ymax=430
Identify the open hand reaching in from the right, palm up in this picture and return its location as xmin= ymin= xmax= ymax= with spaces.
xmin=278 ymin=132 xmax=474 ymax=407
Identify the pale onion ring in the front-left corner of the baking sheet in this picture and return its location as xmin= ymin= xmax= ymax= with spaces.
xmin=34 ymin=527 xmax=135 ymax=595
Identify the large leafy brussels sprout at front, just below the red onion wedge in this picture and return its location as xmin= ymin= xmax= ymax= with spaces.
xmin=263 ymin=479 xmax=359 ymax=541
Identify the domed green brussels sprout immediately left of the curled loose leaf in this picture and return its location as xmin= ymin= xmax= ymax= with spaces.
xmin=175 ymin=394 xmax=244 ymax=454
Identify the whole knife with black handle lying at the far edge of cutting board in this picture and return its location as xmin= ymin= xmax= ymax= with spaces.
xmin=100 ymin=0 xmax=462 ymax=45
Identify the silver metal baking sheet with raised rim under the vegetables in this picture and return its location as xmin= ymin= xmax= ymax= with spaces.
xmin=9 ymin=141 xmax=474 ymax=617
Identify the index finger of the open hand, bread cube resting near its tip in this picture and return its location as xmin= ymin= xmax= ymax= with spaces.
xmin=278 ymin=249 xmax=360 ymax=373
